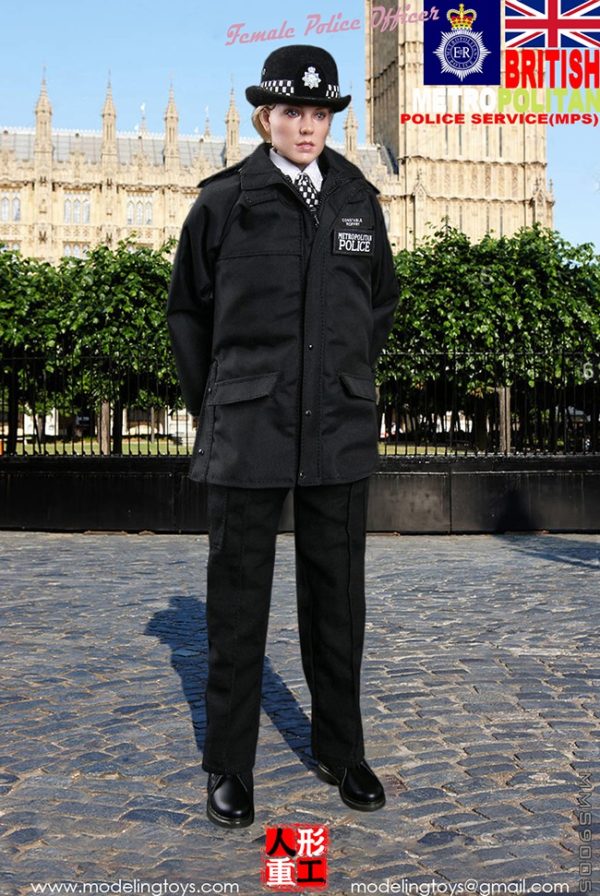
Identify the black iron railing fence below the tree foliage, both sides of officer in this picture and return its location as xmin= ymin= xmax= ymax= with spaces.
xmin=0 ymin=349 xmax=600 ymax=456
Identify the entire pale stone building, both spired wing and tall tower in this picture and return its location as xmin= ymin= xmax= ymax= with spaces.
xmin=0 ymin=18 xmax=554 ymax=261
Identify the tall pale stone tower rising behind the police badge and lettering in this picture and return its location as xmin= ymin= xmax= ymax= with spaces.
xmin=365 ymin=0 xmax=554 ymax=248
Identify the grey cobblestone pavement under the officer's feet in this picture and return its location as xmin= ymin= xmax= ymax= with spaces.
xmin=0 ymin=532 xmax=600 ymax=896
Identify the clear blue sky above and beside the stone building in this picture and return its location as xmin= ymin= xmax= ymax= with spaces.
xmin=0 ymin=0 xmax=600 ymax=252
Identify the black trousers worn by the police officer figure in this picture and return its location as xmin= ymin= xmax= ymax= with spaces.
xmin=202 ymin=478 xmax=369 ymax=773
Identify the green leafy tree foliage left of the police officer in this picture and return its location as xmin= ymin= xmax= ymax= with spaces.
xmin=0 ymin=239 xmax=177 ymax=410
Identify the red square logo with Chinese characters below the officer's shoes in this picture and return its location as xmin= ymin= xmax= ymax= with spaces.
xmin=261 ymin=824 xmax=329 ymax=891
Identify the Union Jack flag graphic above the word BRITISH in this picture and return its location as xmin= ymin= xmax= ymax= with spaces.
xmin=505 ymin=0 xmax=600 ymax=49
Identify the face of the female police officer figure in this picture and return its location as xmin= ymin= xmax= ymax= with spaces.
xmin=262 ymin=103 xmax=332 ymax=168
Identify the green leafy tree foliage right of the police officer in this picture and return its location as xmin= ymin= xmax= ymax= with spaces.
xmin=378 ymin=225 xmax=600 ymax=392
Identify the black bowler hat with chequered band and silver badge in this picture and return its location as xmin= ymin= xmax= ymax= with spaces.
xmin=246 ymin=44 xmax=352 ymax=112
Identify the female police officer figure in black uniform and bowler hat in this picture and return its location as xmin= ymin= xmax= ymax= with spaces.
xmin=168 ymin=45 xmax=398 ymax=827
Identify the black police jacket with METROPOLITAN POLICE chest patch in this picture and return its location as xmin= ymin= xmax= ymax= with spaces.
xmin=167 ymin=143 xmax=398 ymax=488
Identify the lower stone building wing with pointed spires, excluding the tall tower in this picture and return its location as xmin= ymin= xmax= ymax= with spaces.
xmin=0 ymin=80 xmax=393 ymax=261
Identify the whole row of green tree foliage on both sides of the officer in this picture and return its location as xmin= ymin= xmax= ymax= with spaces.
xmin=0 ymin=220 xmax=600 ymax=444
